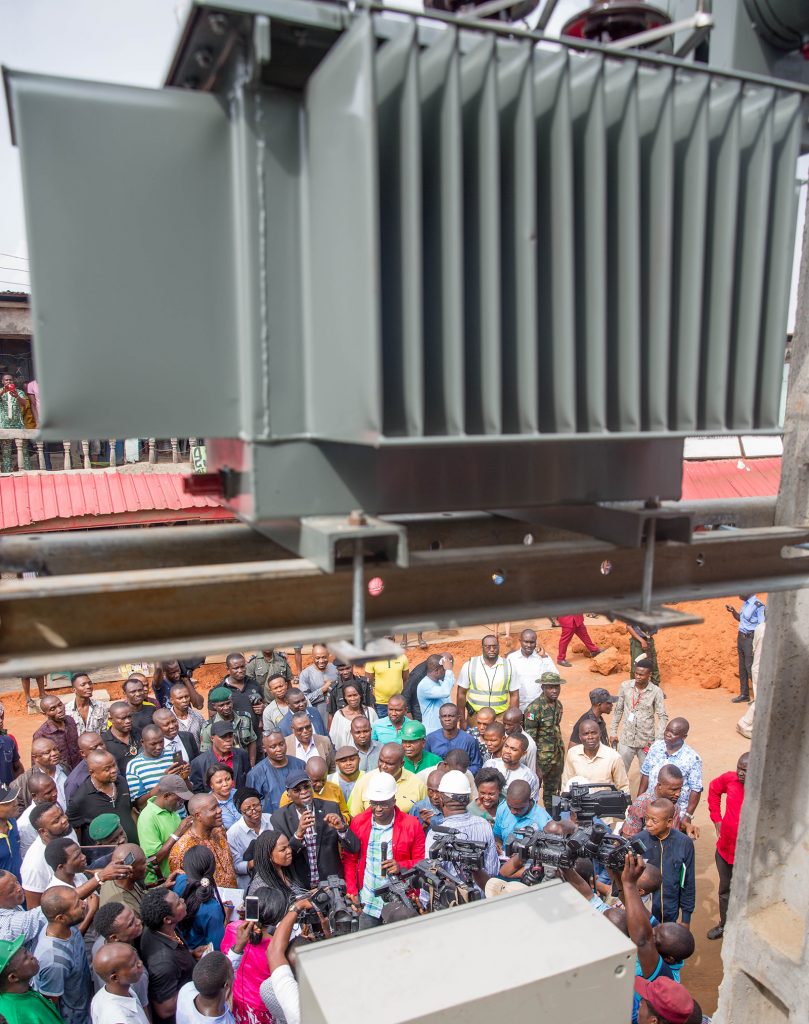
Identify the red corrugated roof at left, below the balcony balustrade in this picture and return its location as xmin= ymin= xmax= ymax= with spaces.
xmin=0 ymin=470 xmax=233 ymax=531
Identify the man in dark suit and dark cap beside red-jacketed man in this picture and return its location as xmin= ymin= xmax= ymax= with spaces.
xmin=270 ymin=771 xmax=359 ymax=888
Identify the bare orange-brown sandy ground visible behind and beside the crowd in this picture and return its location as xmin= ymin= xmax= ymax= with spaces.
xmin=7 ymin=598 xmax=750 ymax=1014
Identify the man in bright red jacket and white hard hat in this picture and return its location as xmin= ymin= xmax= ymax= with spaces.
xmin=343 ymin=772 xmax=424 ymax=930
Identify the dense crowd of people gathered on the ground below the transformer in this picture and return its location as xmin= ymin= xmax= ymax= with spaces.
xmin=0 ymin=610 xmax=761 ymax=1024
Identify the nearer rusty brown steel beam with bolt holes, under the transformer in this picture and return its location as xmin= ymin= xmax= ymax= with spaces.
xmin=0 ymin=523 xmax=809 ymax=675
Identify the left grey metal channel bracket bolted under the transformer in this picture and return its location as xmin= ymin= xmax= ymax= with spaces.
xmin=260 ymin=511 xmax=410 ymax=572
